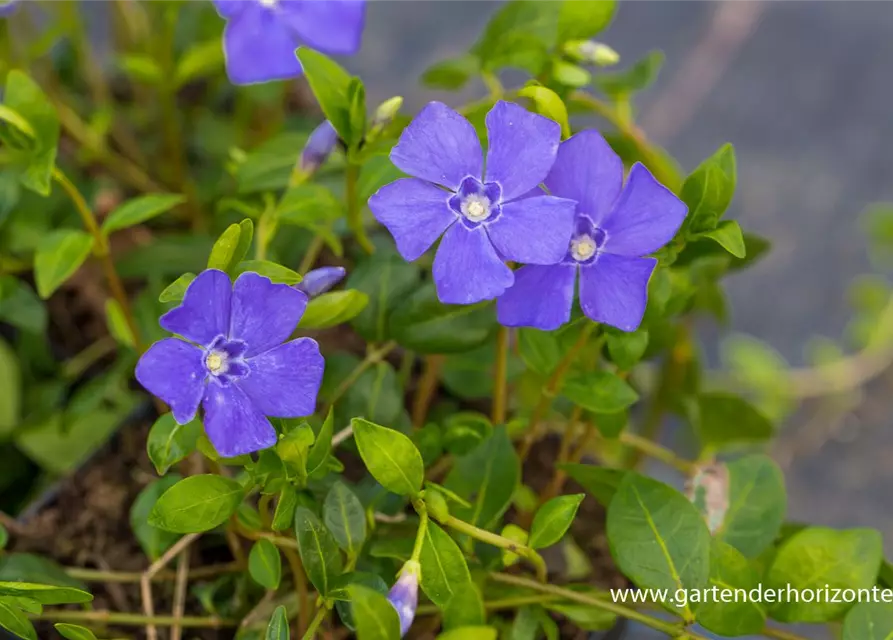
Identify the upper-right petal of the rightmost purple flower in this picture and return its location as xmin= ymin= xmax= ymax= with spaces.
xmin=601 ymin=163 xmax=688 ymax=257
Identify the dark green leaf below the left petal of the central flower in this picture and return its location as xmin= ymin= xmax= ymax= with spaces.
xmin=347 ymin=252 xmax=420 ymax=342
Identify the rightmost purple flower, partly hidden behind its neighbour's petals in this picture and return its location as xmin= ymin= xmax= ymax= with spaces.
xmin=496 ymin=130 xmax=688 ymax=331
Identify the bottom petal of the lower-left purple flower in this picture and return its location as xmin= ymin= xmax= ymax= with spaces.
xmin=202 ymin=380 xmax=276 ymax=458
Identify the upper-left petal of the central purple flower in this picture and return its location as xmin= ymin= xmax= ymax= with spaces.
xmin=391 ymin=102 xmax=483 ymax=191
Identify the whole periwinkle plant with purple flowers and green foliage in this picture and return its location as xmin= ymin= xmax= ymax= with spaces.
xmin=0 ymin=0 xmax=893 ymax=640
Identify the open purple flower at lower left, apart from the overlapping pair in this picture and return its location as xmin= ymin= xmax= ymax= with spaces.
xmin=136 ymin=269 xmax=325 ymax=458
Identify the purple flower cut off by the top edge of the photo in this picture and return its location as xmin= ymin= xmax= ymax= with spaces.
xmin=212 ymin=0 xmax=366 ymax=84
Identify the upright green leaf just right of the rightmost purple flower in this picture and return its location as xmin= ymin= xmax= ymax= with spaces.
xmin=680 ymin=144 xmax=738 ymax=233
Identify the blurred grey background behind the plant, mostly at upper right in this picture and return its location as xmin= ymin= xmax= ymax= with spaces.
xmin=351 ymin=0 xmax=893 ymax=639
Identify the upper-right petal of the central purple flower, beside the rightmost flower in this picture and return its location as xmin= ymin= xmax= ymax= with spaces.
xmin=486 ymin=100 xmax=561 ymax=202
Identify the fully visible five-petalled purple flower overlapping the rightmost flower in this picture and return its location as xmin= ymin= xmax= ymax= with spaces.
xmin=369 ymin=101 xmax=574 ymax=304
